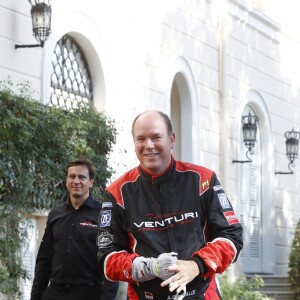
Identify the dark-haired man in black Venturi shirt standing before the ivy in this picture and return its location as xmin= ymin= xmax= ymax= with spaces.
xmin=31 ymin=159 xmax=118 ymax=300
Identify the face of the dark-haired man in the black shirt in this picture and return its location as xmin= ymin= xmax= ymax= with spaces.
xmin=66 ymin=165 xmax=93 ymax=201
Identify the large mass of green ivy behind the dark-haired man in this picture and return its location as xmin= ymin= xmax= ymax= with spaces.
xmin=0 ymin=81 xmax=117 ymax=296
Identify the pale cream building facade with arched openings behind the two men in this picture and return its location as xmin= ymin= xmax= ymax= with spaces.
xmin=0 ymin=0 xmax=300 ymax=296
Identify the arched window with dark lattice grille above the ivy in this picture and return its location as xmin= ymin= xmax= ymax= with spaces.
xmin=50 ymin=35 xmax=93 ymax=110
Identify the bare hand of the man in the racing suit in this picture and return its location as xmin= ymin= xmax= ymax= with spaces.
xmin=161 ymin=260 xmax=199 ymax=294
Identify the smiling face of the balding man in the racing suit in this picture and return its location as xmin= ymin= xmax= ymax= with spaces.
xmin=133 ymin=112 xmax=175 ymax=175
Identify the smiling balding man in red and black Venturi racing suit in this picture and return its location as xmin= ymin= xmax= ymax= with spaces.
xmin=98 ymin=111 xmax=243 ymax=300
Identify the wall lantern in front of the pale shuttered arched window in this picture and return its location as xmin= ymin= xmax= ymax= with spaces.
xmin=232 ymin=112 xmax=258 ymax=164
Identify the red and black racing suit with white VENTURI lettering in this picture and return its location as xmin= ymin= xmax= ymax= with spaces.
xmin=97 ymin=157 xmax=243 ymax=300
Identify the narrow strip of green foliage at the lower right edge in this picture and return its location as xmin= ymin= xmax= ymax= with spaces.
xmin=288 ymin=220 xmax=300 ymax=299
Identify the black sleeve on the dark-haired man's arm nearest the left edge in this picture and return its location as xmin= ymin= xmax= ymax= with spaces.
xmin=30 ymin=218 xmax=53 ymax=300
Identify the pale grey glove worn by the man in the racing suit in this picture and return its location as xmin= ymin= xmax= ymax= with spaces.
xmin=132 ymin=252 xmax=177 ymax=282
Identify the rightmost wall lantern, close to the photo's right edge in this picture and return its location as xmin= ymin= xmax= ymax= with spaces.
xmin=275 ymin=129 xmax=300 ymax=174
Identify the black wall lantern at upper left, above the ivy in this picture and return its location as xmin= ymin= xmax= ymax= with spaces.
xmin=15 ymin=0 xmax=52 ymax=49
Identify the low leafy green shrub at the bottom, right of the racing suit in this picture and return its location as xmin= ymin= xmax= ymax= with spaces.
xmin=219 ymin=274 xmax=271 ymax=300
